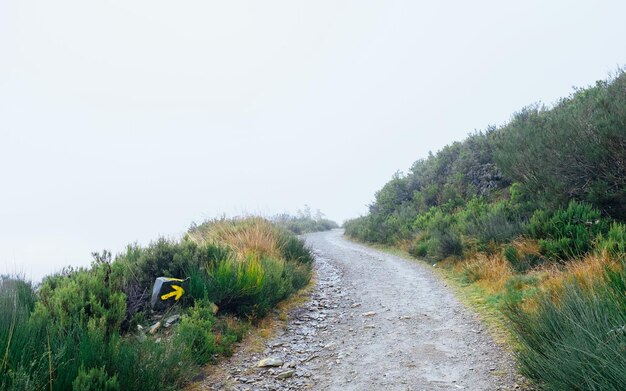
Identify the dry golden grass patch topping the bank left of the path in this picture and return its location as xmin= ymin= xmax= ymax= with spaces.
xmin=189 ymin=217 xmax=281 ymax=259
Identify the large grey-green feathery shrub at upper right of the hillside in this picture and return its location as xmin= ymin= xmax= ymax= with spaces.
xmin=494 ymin=72 xmax=626 ymax=219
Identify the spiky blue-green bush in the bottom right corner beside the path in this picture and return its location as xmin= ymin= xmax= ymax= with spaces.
xmin=507 ymin=263 xmax=626 ymax=391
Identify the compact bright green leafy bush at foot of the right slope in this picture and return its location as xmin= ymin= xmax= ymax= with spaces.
xmin=528 ymin=201 xmax=609 ymax=260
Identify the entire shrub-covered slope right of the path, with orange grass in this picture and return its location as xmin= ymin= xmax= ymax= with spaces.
xmin=344 ymin=71 xmax=626 ymax=390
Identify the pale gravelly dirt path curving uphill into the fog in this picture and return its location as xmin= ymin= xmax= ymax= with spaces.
xmin=197 ymin=230 xmax=519 ymax=390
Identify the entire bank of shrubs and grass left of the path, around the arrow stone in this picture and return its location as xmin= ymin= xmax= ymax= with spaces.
xmin=0 ymin=218 xmax=313 ymax=391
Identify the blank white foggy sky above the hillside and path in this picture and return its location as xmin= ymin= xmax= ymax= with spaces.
xmin=0 ymin=0 xmax=626 ymax=279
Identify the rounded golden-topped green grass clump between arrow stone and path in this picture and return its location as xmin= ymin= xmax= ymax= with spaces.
xmin=189 ymin=218 xmax=313 ymax=319
